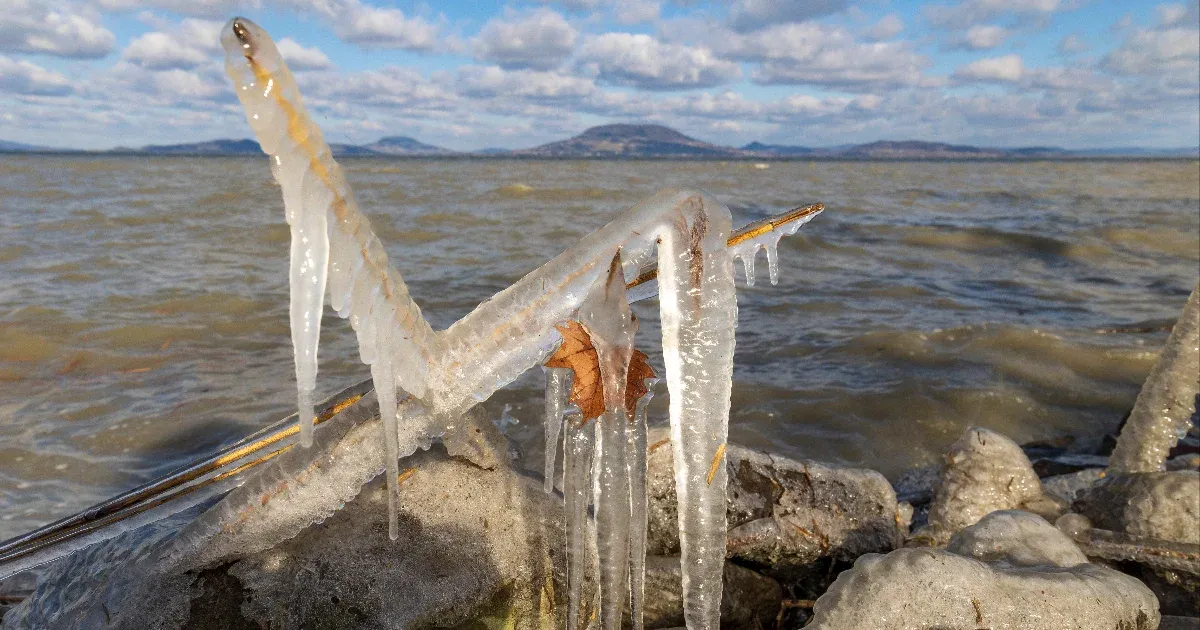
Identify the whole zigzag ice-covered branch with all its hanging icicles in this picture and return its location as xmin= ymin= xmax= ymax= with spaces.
xmin=224 ymin=18 xmax=820 ymax=628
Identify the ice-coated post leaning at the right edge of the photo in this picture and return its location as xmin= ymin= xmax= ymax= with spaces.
xmin=1109 ymin=283 xmax=1200 ymax=473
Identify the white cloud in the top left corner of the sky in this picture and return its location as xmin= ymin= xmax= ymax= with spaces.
xmin=0 ymin=0 xmax=116 ymax=59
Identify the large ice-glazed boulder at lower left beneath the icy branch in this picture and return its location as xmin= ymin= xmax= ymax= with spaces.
xmin=4 ymin=446 xmax=566 ymax=630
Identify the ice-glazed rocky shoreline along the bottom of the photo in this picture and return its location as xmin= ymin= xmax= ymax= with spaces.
xmin=4 ymin=410 xmax=1200 ymax=630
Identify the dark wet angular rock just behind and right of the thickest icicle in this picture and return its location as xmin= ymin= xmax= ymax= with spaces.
xmin=647 ymin=431 xmax=911 ymax=580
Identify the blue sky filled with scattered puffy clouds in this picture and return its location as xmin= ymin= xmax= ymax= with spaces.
xmin=0 ymin=0 xmax=1200 ymax=150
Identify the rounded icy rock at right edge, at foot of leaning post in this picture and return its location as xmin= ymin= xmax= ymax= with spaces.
xmin=1074 ymin=470 xmax=1200 ymax=544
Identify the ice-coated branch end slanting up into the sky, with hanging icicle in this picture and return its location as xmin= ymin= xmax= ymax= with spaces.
xmin=221 ymin=18 xmax=439 ymax=444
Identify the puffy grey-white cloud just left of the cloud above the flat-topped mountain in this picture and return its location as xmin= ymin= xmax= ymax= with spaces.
xmin=473 ymin=10 xmax=578 ymax=70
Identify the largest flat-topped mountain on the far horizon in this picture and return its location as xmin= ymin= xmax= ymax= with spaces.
xmin=512 ymin=125 xmax=746 ymax=158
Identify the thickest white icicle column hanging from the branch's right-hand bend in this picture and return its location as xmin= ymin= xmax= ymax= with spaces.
xmin=659 ymin=198 xmax=737 ymax=629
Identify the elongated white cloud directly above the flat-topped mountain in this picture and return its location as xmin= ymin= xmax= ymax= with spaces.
xmin=578 ymin=32 xmax=742 ymax=90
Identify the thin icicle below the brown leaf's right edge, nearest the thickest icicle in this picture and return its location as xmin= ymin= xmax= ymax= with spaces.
xmin=625 ymin=382 xmax=654 ymax=630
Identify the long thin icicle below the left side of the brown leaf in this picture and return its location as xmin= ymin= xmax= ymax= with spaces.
xmin=563 ymin=413 xmax=595 ymax=629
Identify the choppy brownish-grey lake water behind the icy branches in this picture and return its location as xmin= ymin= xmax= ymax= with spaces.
xmin=0 ymin=156 xmax=1200 ymax=538
